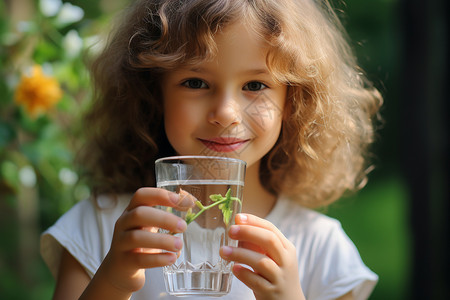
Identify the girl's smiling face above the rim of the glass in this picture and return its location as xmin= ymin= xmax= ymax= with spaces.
xmin=162 ymin=24 xmax=287 ymax=166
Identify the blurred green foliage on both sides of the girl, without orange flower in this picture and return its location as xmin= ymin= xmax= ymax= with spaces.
xmin=0 ymin=0 xmax=410 ymax=300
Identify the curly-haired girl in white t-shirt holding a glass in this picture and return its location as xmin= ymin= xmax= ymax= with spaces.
xmin=42 ymin=0 xmax=381 ymax=300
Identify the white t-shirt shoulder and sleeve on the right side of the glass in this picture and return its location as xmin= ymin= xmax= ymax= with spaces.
xmin=268 ymin=198 xmax=378 ymax=299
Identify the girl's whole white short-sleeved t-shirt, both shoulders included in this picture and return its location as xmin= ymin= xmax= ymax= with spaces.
xmin=41 ymin=195 xmax=378 ymax=300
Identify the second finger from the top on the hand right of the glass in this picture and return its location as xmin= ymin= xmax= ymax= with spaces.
xmin=228 ymin=225 xmax=286 ymax=265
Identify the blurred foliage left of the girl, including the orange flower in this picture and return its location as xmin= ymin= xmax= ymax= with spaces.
xmin=0 ymin=0 xmax=123 ymax=299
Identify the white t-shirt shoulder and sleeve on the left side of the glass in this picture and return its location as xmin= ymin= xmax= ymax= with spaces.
xmin=40 ymin=195 xmax=130 ymax=276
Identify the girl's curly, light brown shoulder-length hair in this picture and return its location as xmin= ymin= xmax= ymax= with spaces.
xmin=80 ymin=0 xmax=382 ymax=207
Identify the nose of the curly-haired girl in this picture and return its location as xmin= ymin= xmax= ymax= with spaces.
xmin=208 ymin=95 xmax=241 ymax=128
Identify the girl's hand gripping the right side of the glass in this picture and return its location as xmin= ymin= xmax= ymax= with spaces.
xmin=220 ymin=214 xmax=305 ymax=300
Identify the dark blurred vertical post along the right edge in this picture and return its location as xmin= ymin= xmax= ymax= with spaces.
xmin=401 ymin=0 xmax=450 ymax=299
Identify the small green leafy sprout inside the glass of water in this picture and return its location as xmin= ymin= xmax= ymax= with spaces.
xmin=185 ymin=189 xmax=242 ymax=226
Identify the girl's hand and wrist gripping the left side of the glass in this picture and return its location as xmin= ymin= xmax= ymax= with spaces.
xmin=94 ymin=188 xmax=194 ymax=294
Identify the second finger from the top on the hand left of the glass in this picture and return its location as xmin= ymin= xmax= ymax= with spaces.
xmin=117 ymin=206 xmax=187 ymax=233
